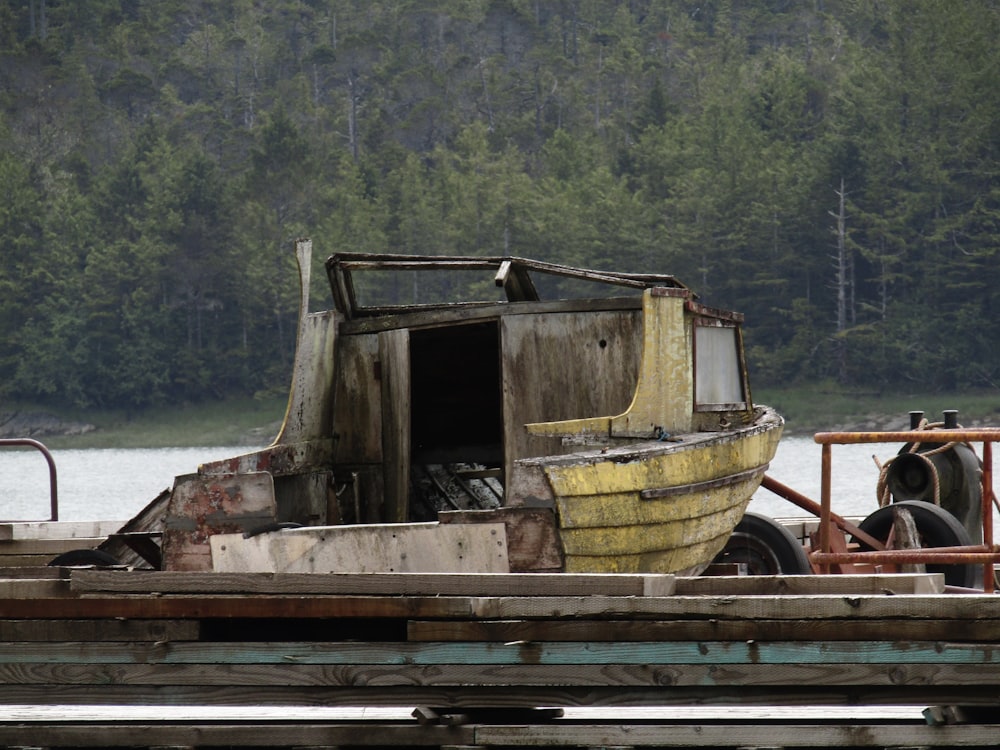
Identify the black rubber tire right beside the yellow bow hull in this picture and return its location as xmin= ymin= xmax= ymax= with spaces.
xmin=713 ymin=513 xmax=812 ymax=576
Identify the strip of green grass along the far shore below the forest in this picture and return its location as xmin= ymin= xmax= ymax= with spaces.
xmin=0 ymin=384 xmax=1000 ymax=449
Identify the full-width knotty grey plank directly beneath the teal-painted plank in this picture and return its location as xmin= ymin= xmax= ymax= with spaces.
xmin=0 ymin=660 xmax=1000 ymax=688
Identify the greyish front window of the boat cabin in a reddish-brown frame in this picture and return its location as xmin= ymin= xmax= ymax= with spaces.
xmin=694 ymin=319 xmax=747 ymax=411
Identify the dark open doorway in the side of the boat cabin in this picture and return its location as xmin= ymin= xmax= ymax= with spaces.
xmin=409 ymin=320 xmax=504 ymax=520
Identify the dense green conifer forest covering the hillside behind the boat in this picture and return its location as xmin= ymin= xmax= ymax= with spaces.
xmin=0 ymin=0 xmax=1000 ymax=410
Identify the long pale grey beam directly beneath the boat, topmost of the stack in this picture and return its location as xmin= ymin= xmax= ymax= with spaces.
xmin=71 ymin=570 xmax=675 ymax=597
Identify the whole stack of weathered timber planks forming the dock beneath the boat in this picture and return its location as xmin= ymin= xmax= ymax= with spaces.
xmin=0 ymin=568 xmax=1000 ymax=748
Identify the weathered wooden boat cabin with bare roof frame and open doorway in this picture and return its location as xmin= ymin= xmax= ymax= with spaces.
xmin=327 ymin=255 xmax=749 ymax=522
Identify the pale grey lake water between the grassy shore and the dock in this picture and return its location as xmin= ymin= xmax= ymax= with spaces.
xmin=0 ymin=436 xmax=996 ymax=521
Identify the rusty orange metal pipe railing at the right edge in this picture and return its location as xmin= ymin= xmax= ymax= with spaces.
xmin=811 ymin=428 xmax=1000 ymax=593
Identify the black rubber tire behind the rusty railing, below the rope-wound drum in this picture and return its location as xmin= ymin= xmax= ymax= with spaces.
xmin=851 ymin=500 xmax=982 ymax=588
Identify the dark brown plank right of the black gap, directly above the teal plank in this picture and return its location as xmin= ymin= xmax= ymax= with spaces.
xmin=407 ymin=618 xmax=1000 ymax=642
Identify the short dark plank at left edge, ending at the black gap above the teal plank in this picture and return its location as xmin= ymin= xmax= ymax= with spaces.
xmin=0 ymin=618 xmax=201 ymax=642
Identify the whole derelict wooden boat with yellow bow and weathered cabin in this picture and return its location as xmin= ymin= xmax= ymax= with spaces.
xmin=107 ymin=240 xmax=783 ymax=574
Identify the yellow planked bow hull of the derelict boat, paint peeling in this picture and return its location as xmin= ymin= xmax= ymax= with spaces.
xmin=525 ymin=408 xmax=783 ymax=575
